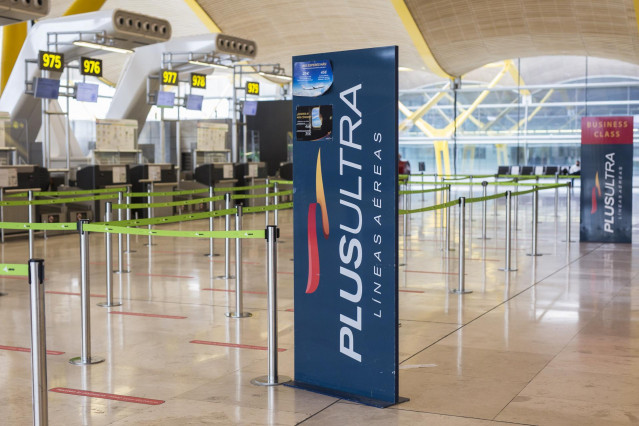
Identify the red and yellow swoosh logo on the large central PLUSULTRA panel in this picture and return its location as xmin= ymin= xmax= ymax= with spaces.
xmin=306 ymin=151 xmax=329 ymax=293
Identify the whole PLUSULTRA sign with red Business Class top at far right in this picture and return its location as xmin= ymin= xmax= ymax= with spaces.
xmin=579 ymin=117 xmax=633 ymax=243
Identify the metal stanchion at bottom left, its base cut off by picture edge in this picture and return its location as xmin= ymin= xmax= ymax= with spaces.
xmin=29 ymin=259 xmax=49 ymax=426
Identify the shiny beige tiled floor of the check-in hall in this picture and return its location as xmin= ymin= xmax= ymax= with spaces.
xmin=0 ymin=187 xmax=639 ymax=426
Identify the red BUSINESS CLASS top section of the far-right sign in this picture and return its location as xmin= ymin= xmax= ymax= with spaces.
xmin=581 ymin=117 xmax=632 ymax=145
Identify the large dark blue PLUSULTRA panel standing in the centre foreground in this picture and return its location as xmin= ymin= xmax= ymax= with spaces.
xmin=292 ymin=46 xmax=400 ymax=407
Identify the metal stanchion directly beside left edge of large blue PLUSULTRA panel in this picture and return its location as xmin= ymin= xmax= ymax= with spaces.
xmin=251 ymin=225 xmax=291 ymax=386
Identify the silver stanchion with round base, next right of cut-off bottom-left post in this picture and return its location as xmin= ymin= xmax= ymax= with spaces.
xmin=69 ymin=219 xmax=104 ymax=365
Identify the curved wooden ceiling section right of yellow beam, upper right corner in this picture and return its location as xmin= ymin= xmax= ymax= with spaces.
xmin=404 ymin=0 xmax=639 ymax=75
